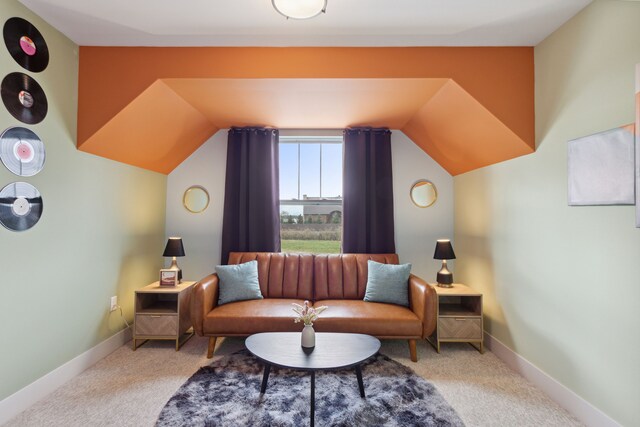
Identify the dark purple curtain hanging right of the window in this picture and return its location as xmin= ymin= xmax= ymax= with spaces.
xmin=342 ymin=128 xmax=396 ymax=253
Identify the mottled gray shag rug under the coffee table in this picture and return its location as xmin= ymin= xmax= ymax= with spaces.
xmin=156 ymin=350 xmax=464 ymax=427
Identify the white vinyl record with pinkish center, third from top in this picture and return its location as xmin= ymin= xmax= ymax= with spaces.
xmin=0 ymin=127 xmax=46 ymax=176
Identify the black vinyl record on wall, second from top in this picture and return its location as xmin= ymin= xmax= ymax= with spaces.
xmin=0 ymin=73 xmax=48 ymax=125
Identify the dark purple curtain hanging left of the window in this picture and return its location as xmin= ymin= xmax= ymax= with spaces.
xmin=221 ymin=128 xmax=280 ymax=264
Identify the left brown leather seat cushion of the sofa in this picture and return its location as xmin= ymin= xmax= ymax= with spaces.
xmin=203 ymin=298 xmax=304 ymax=336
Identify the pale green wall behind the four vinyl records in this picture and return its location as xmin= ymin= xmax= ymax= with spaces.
xmin=0 ymin=0 xmax=166 ymax=400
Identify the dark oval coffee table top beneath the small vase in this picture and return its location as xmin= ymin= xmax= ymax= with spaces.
xmin=245 ymin=332 xmax=380 ymax=371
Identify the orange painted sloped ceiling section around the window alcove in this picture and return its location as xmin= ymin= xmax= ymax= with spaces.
xmin=78 ymin=47 xmax=535 ymax=175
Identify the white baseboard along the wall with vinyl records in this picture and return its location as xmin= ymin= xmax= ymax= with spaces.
xmin=0 ymin=328 xmax=131 ymax=425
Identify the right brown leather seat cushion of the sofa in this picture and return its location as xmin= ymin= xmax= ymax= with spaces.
xmin=313 ymin=299 xmax=422 ymax=337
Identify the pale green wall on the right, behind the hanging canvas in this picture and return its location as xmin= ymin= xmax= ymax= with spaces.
xmin=454 ymin=1 xmax=640 ymax=426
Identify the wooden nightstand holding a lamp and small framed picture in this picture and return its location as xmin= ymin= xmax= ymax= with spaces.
xmin=133 ymin=281 xmax=196 ymax=351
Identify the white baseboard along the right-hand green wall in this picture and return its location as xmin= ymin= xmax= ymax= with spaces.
xmin=484 ymin=332 xmax=620 ymax=427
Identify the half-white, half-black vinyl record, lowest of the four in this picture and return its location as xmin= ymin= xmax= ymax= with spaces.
xmin=0 ymin=182 xmax=42 ymax=231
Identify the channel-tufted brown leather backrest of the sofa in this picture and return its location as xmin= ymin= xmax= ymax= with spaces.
xmin=229 ymin=252 xmax=398 ymax=300
